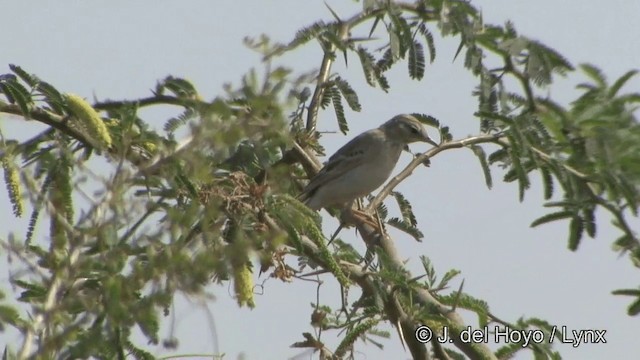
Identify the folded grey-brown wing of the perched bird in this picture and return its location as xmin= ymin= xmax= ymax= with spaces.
xmin=300 ymin=129 xmax=380 ymax=199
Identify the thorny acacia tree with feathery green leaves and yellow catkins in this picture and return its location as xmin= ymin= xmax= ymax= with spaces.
xmin=0 ymin=0 xmax=640 ymax=359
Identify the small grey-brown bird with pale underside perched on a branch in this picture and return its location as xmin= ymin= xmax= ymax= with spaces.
xmin=298 ymin=114 xmax=438 ymax=210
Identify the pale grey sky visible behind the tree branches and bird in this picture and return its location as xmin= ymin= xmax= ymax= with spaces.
xmin=0 ymin=0 xmax=640 ymax=360
